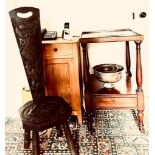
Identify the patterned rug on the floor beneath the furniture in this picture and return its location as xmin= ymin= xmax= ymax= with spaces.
xmin=5 ymin=109 xmax=149 ymax=155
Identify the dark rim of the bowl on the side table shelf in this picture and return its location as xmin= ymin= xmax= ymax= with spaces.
xmin=93 ymin=63 xmax=124 ymax=73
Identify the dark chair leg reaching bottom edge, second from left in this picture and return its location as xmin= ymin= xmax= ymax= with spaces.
xmin=32 ymin=131 xmax=40 ymax=155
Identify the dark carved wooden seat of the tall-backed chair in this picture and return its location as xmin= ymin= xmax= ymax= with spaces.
xmin=19 ymin=96 xmax=72 ymax=131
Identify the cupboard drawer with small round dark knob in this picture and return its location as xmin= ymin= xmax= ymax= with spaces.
xmin=43 ymin=44 xmax=73 ymax=59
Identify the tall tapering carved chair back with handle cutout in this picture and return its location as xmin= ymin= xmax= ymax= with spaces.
xmin=10 ymin=7 xmax=45 ymax=104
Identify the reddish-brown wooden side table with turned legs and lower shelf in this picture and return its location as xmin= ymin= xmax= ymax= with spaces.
xmin=79 ymin=29 xmax=144 ymax=132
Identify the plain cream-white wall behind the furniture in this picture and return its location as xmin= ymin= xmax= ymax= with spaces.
xmin=6 ymin=0 xmax=148 ymax=115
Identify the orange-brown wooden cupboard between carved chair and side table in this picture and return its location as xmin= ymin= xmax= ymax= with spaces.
xmin=42 ymin=37 xmax=82 ymax=124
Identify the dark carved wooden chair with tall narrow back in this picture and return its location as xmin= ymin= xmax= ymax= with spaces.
xmin=9 ymin=7 xmax=78 ymax=155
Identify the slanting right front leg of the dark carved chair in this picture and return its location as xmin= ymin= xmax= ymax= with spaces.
xmin=63 ymin=122 xmax=79 ymax=155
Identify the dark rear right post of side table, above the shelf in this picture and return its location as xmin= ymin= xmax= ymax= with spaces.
xmin=126 ymin=41 xmax=132 ymax=77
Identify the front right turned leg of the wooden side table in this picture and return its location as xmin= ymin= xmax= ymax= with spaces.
xmin=135 ymin=41 xmax=144 ymax=132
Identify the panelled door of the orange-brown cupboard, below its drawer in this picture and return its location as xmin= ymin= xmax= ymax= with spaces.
xmin=44 ymin=59 xmax=74 ymax=110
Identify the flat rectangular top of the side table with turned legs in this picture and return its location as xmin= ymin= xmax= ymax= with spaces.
xmin=80 ymin=29 xmax=144 ymax=43
